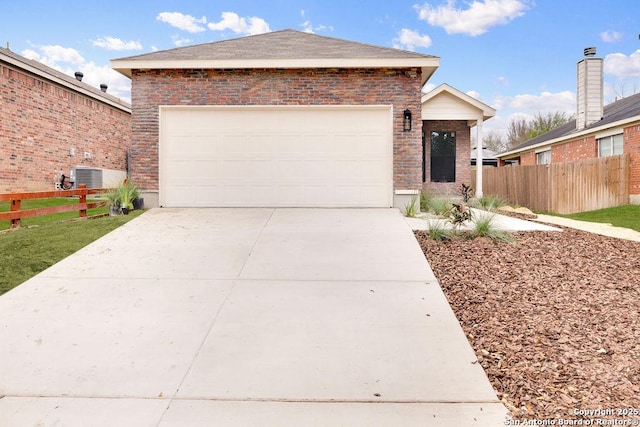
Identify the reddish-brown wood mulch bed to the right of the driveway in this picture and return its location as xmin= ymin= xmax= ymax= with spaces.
xmin=415 ymin=229 xmax=640 ymax=425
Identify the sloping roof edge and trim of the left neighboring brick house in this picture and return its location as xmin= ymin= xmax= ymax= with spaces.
xmin=0 ymin=47 xmax=131 ymax=112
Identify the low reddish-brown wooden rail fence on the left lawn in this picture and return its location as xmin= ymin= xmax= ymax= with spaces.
xmin=0 ymin=184 xmax=107 ymax=228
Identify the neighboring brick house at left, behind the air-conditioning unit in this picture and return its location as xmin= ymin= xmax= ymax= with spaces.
xmin=0 ymin=48 xmax=131 ymax=192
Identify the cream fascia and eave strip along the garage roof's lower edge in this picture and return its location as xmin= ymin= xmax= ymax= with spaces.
xmin=111 ymin=57 xmax=440 ymax=84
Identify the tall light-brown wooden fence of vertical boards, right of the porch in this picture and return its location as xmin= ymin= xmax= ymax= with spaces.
xmin=472 ymin=154 xmax=629 ymax=214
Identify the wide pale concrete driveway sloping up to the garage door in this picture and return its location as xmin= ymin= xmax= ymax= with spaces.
xmin=0 ymin=209 xmax=507 ymax=427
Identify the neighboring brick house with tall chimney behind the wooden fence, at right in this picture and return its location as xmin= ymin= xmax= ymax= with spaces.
xmin=497 ymin=49 xmax=640 ymax=204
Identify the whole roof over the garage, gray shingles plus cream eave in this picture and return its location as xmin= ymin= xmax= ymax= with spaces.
xmin=111 ymin=30 xmax=439 ymax=83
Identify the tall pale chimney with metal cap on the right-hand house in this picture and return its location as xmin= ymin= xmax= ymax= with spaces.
xmin=576 ymin=47 xmax=604 ymax=130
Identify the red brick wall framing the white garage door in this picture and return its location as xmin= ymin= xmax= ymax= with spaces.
xmin=131 ymin=69 xmax=422 ymax=191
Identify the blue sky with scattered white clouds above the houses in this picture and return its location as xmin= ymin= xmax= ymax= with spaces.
xmin=0 ymin=0 xmax=640 ymax=137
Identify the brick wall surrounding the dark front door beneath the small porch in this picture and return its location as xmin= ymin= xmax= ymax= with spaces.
xmin=422 ymin=120 xmax=471 ymax=195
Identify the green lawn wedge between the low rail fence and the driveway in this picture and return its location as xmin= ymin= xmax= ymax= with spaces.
xmin=0 ymin=210 xmax=144 ymax=295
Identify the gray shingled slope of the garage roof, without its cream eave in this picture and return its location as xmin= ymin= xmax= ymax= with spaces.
xmin=118 ymin=29 xmax=437 ymax=61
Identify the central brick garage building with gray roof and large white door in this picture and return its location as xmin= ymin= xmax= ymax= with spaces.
xmin=111 ymin=30 xmax=496 ymax=207
